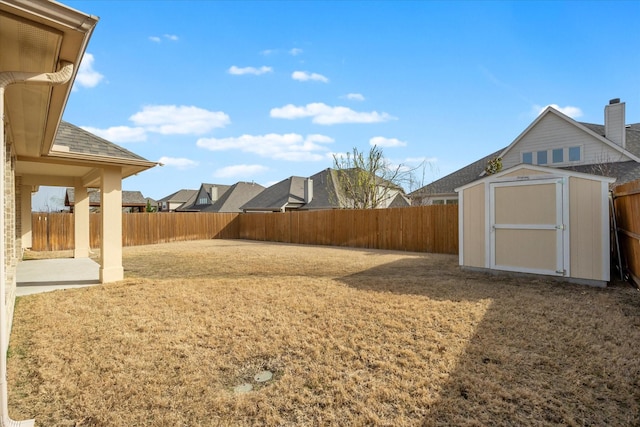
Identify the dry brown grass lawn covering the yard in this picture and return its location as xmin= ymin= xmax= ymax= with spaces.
xmin=9 ymin=240 xmax=640 ymax=426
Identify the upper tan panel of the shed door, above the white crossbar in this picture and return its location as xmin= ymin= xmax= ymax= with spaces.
xmin=495 ymin=184 xmax=556 ymax=224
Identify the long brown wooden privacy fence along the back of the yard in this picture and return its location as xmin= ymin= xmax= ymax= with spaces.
xmin=32 ymin=205 xmax=458 ymax=254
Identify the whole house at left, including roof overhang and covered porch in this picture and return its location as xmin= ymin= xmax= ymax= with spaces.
xmin=0 ymin=0 xmax=156 ymax=426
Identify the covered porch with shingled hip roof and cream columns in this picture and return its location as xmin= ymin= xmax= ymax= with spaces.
xmin=16 ymin=121 xmax=156 ymax=283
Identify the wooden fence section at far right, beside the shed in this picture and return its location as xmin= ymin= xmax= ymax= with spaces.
xmin=612 ymin=180 xmax=640 ymax=286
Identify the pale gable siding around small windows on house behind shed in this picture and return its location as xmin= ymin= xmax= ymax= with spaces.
xmin=502 ymin=114 xmax=630 ymax=169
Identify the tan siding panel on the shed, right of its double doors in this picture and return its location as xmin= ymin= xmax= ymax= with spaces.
xmin=569 ymin=177 xmax=606 ymax=280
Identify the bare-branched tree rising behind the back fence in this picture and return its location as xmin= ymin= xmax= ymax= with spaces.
xmin=333 ymin=145 xmax=413 ymax=209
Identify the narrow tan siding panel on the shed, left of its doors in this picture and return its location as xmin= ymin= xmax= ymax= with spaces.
xmin=461 ymin=184 xmax=485 ymax=267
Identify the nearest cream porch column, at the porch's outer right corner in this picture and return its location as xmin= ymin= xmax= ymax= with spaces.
xmin=100 ymin=168 xmax=124 ymax=283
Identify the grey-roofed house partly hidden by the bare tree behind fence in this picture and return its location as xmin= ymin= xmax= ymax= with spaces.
xmin=242 ymin=168 xmax=409 ymax=212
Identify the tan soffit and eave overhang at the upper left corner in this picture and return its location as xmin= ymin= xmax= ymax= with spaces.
xmin=0 ymin=0 xmax=98 ymax=158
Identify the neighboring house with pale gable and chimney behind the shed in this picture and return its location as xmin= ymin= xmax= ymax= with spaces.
xmin=409 ymin=99 xmax=640 ymax=205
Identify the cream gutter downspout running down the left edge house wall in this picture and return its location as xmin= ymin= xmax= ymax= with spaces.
xmin=0 ymin=61 xmax=73 ymax=427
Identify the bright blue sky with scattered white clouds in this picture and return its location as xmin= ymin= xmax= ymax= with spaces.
xmin=34 ymin=0 xmax=640 ymax=208
